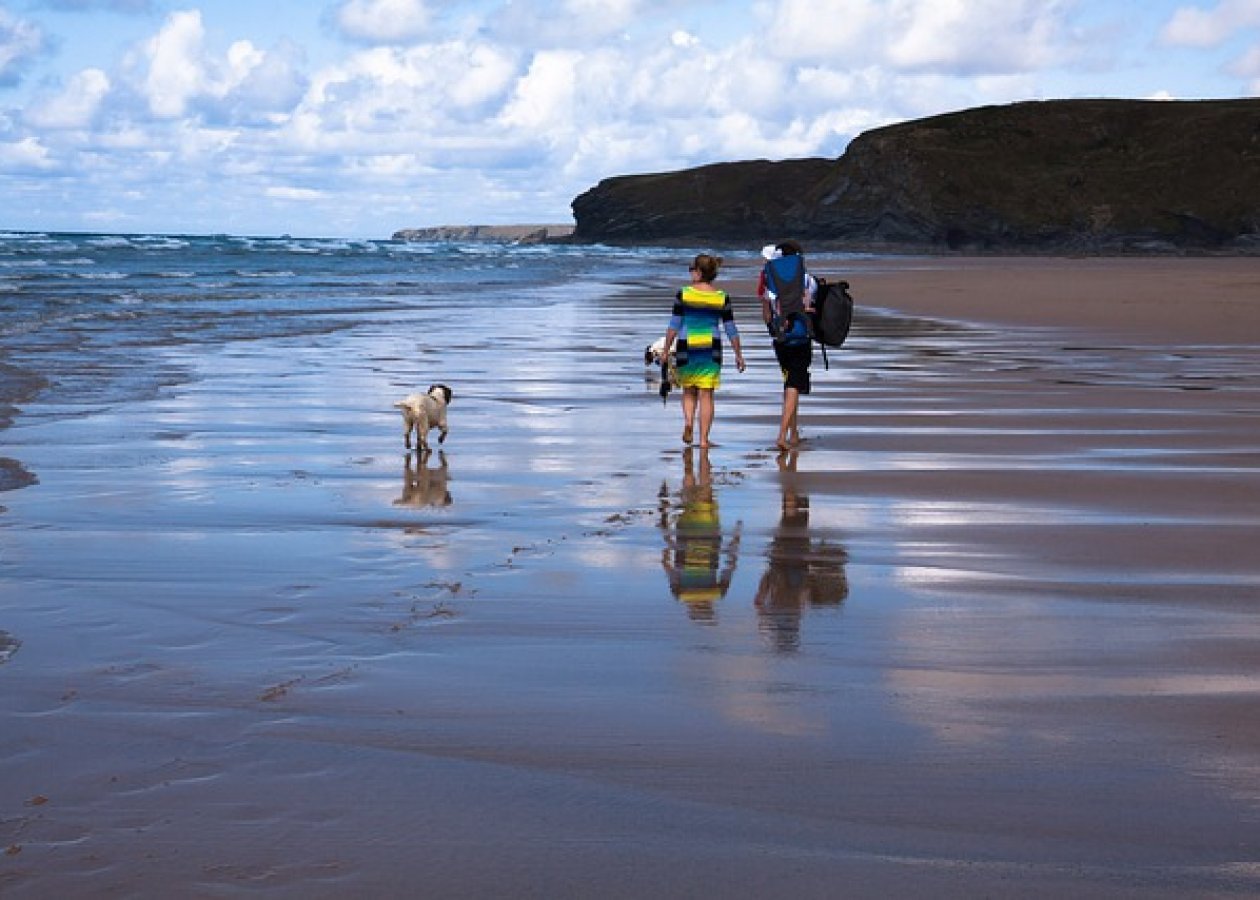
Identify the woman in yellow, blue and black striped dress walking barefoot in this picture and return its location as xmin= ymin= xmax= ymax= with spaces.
xmin=664 ymin=253 xmax=743 ymax=449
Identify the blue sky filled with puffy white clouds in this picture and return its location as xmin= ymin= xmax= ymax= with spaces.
xmin=0 ymin=0 xmax=1260 ymax=238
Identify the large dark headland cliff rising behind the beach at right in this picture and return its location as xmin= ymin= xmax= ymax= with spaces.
xmin=572 ymin=100 xmax=1260 ymax=252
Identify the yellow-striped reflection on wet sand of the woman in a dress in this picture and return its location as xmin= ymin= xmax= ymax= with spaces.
xmin=660 ymin=447 xmax=740 ymax=623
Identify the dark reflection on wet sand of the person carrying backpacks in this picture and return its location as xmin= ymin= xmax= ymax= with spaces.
xmin=753 ymin=450 xmax=849 ymax=652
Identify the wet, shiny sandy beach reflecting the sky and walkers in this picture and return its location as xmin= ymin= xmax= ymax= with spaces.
xmin=0 ymin=258 xmax=1260 ymax=897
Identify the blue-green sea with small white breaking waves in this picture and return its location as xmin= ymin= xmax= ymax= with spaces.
xmin=0 ymin=232 xmax=710 ymax=423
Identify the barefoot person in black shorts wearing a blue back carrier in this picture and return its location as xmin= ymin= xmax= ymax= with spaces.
xmin=757 ymin=241 xmax=818 ymax=450
